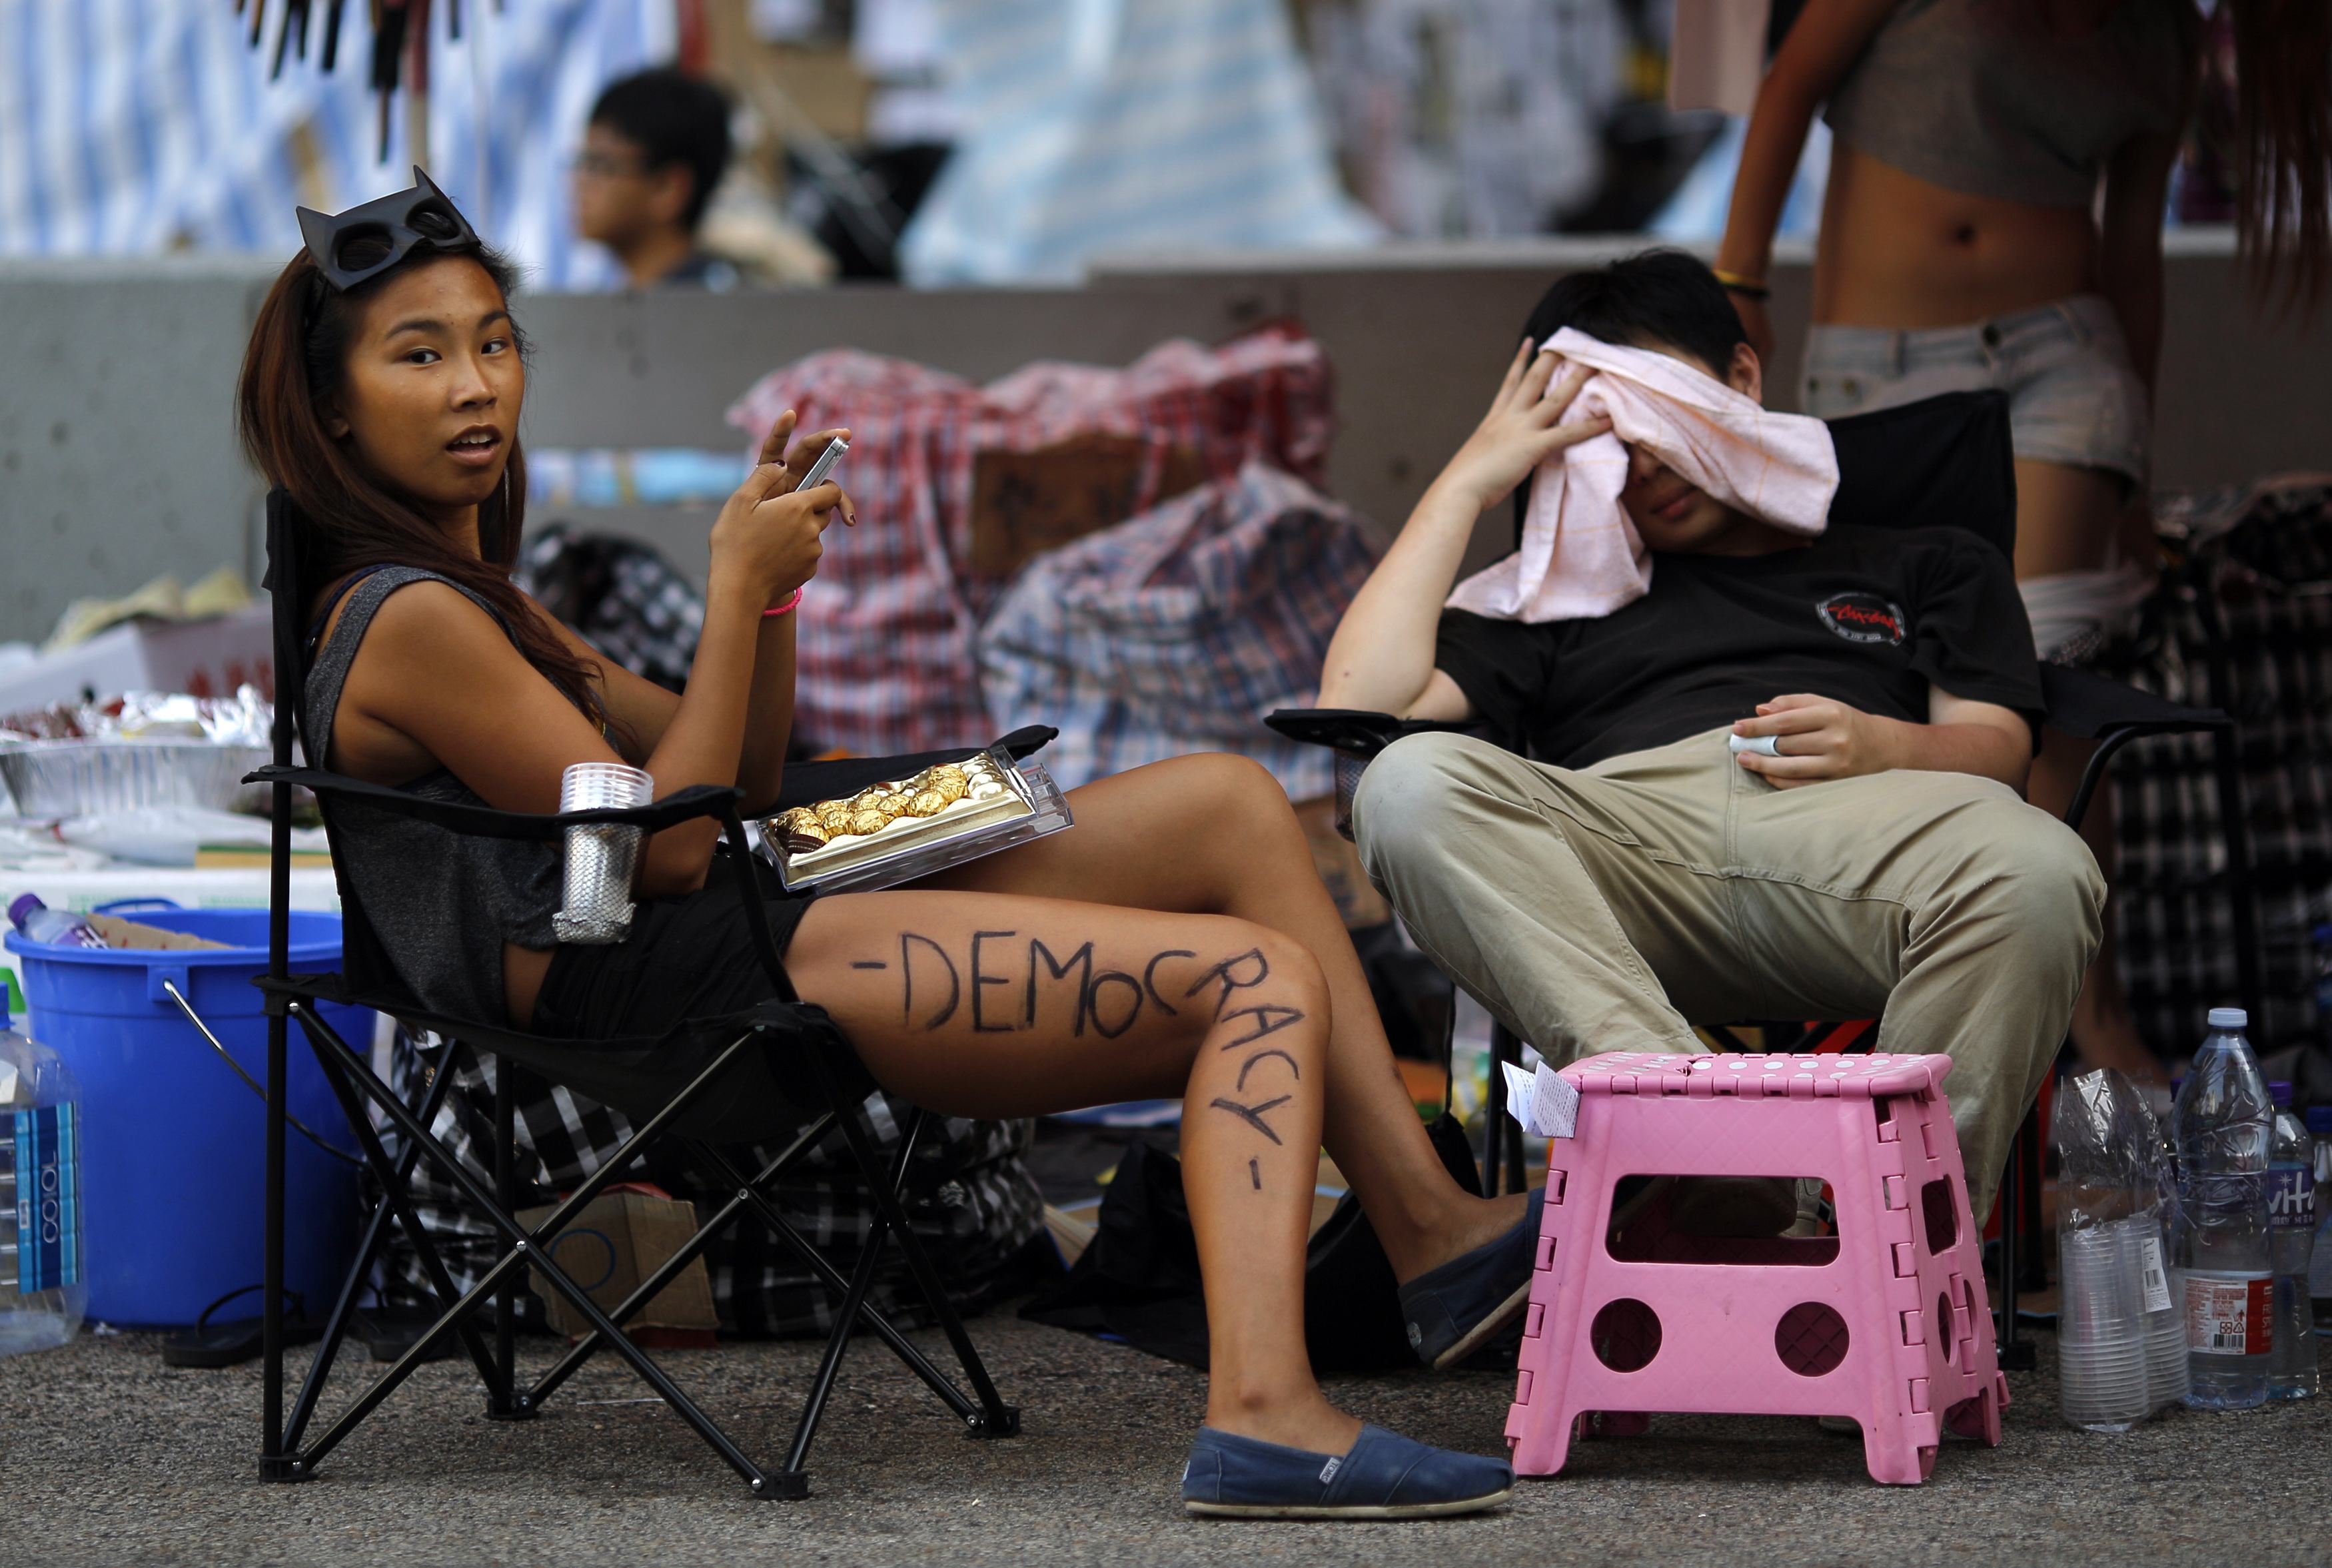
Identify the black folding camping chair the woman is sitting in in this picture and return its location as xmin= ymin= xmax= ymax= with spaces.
xmin=250 ymin=492 xmax=1031 ymax=1498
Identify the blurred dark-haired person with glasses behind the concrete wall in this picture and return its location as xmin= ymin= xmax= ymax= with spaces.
xmin=574 ymin=65 xmax=740 ymax=291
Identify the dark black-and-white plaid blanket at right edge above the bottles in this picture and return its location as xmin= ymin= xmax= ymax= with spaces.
xmin=2094 ymin=480 xmax=2332 ymax=1058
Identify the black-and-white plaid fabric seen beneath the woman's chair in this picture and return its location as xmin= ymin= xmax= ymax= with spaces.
xmin=366 ymin=1032 xmax=1045 ymax=1338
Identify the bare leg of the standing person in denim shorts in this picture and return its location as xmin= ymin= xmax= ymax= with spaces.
xmin=2018 ymin=462 xmax=2164 ymax=1083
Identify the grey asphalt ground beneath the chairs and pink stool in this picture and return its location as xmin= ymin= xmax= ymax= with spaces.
xmin=0 ymin=1314 xmax=2332 ymax=1568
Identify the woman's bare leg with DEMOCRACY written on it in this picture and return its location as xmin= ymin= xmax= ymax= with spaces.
xmin=786 ymin=890 xmax=1360 ymax=1454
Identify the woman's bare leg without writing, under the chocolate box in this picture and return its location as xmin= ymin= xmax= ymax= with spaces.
xmin=923 ymin=753 xmax=1525 ymax=1282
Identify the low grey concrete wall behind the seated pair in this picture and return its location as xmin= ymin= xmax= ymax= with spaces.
xmin=0 ymin=235 xmax=2332 ymax=641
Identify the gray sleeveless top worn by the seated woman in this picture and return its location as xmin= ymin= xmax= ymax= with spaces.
xmin=301 ymin=566 xmax=560 ymax=1023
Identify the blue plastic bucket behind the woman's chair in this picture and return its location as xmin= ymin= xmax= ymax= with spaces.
xmin=7 ymin=907 xmax=373 ymax=1328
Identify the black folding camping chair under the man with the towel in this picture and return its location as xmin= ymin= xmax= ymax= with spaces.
xmin=1267 ymin=392 xmax=2262 ymax=1368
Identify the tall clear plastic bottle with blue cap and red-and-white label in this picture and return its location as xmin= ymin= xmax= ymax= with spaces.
xmin=2171 ymin=1006 xmax=2274 ymax=1409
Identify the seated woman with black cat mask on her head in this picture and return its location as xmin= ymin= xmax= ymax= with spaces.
xmin=241 ymin=177 xmax=1537 ymax=1517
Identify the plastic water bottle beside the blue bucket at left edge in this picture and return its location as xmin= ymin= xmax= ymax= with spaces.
xmin=0 ymin=969 xmax=89 ymax=1356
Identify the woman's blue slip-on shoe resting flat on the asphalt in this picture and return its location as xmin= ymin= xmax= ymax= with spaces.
xmin=1183 ymin=1426 xmax=1514 ymax=1519
